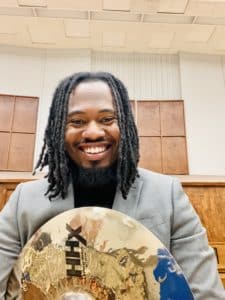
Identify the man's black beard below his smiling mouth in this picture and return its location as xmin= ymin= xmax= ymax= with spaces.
xmin=69 ymin=163 xmax=117 ymax=188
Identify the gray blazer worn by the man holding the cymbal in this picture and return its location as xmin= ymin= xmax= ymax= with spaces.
xmin=0 ymin=169 xmax=225 ymax=300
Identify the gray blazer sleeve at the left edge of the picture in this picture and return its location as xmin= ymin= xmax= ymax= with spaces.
xmin=0 ymin=185 xmax=21 ymax=299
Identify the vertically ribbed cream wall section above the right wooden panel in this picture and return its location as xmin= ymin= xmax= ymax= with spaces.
xmin=91 ymin=52 xmax=181 ymax=100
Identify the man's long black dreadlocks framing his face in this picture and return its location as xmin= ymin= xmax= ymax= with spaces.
xmin=34 ymin=72 xmax=139 ymax=199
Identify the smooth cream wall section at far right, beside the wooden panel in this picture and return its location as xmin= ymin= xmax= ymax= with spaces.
xmin=180 ymin=54 xmax=225 ymax=175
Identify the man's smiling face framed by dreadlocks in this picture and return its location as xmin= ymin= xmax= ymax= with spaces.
xmin=65 ymin=81 xmax=120 ymax=168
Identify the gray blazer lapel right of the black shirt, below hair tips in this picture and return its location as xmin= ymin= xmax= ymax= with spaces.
xmin=112 ymin=177 xmax=143 ymax=218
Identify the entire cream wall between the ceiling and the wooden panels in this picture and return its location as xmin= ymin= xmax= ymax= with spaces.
xmin=0 ymin=47 xmax=225 ymax=175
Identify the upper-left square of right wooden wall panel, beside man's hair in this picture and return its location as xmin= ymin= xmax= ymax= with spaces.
xmin=137 ymin=101 xmax=161 ymax=136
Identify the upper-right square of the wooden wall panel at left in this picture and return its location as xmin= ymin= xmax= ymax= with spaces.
xmin=12 ymin=97 xmax=38 ymax=133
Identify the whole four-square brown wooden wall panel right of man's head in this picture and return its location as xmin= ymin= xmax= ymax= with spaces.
xmin=136 ymin=100 xmax=188 ymax=174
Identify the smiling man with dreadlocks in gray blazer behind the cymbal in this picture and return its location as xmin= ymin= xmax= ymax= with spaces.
xmin=0 ymin=73 xmax=225 ymax=300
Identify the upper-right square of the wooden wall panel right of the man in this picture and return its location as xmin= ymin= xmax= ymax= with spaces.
xmin=160 ymin=101 xmax=185 ymax=136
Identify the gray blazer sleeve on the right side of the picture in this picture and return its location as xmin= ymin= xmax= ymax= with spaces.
xmin=171 ymin=179 xmax=225 ymax=300
